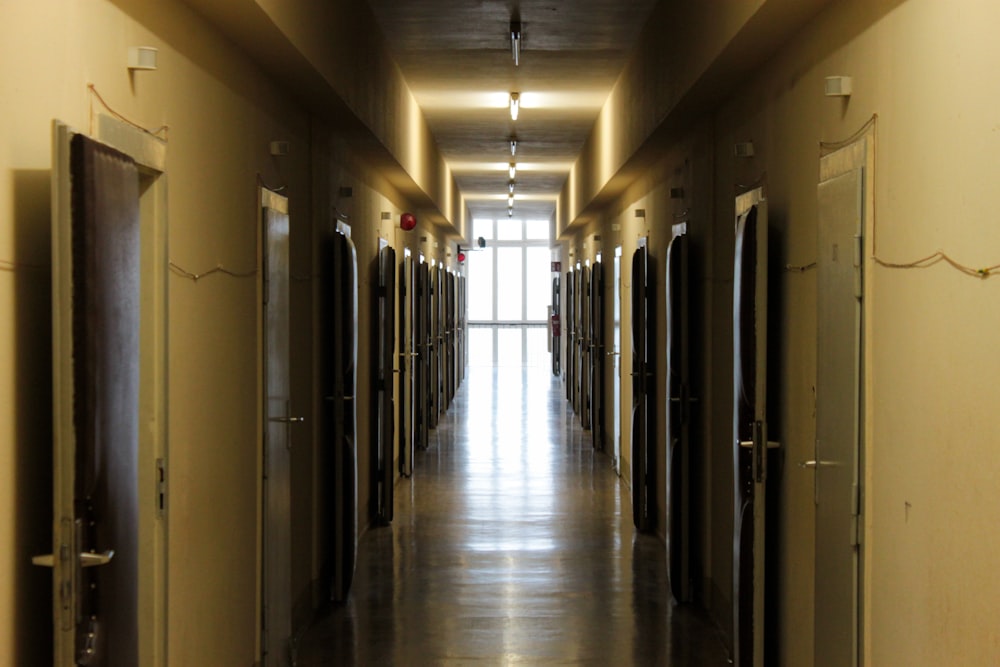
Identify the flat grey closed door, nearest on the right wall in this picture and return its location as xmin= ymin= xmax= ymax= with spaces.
xmin=816 ymin=163 xmax=864 ymax=667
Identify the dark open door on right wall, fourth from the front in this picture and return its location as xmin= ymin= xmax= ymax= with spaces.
xmin=632 ymin=239 xmax=656 ymax=531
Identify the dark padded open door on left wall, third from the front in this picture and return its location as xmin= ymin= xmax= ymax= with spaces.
xmin=322 ymin=231 xmax=358 ymax=600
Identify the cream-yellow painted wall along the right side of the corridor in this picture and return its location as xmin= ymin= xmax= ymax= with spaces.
xmin=562 ymin=0 xmax=1000 ymax=665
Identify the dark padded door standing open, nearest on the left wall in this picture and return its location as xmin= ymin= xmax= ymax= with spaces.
xmin=44 ymin=128 xmax=142 ymax=666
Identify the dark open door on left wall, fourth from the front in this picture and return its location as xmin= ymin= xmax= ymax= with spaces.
xmin=375 ymin=247 xmax=396 ymax=523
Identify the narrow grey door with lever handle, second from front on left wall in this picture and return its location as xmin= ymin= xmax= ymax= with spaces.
xmin=260 ymin=188 xmax=292 ymax=666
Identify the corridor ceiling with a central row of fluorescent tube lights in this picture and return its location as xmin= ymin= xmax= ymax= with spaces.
xmin=369 ymin=0 xmax=655 ymax=226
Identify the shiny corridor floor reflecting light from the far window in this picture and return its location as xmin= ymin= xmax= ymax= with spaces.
xmin=297 ymin=358 xmax=727 ymax=667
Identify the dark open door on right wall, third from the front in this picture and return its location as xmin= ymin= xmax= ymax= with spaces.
xmin=666 ymin=223 xmax=693 ymax=602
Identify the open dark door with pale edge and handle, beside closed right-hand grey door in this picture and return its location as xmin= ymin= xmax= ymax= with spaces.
xmin=733 ymin=189 xmax=772 ymax=667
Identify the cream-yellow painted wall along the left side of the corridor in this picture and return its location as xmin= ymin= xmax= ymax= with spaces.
xmin=0 ymin=0 xmax=446 ymax=665
